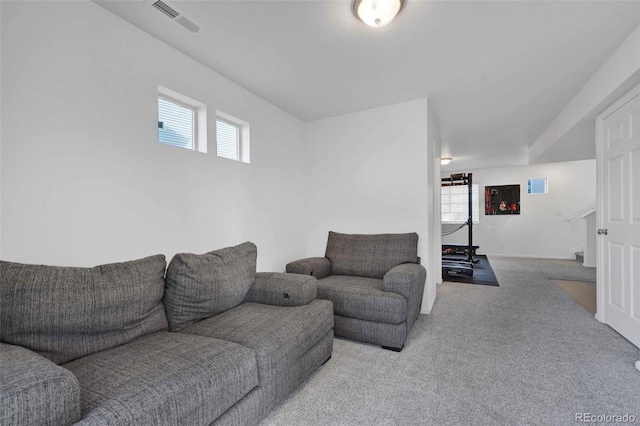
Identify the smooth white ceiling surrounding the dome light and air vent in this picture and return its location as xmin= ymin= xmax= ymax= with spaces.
xmin=96 ymin=0 xmax=640 ymax=170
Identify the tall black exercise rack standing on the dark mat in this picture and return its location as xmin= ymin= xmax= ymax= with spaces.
xmin=442 ymin=173 xmax=479 ymax=277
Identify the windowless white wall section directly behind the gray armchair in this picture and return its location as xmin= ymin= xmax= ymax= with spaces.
xmin=304 ymin=99 xmax=435 ymax=312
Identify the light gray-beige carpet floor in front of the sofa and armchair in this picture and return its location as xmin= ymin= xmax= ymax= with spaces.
xmin=261 ymin=257 xmax=640 ymax=426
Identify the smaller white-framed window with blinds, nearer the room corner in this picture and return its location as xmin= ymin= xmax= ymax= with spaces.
xmin=216 ymin=111 xmax=250 ymax=163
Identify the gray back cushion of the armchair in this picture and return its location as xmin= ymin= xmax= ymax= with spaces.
xmin=325 ymin=231 xmax=418 ymax=278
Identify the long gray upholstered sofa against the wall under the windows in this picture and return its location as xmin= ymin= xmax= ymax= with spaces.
xmin=0 ymin=243 xmax=333 ymax=426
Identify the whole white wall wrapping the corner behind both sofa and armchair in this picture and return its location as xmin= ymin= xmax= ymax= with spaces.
xmin=0 ymin=2 xmax=440 ymax=312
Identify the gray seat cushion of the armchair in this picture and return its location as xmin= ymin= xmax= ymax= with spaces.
xmin=318 ymin=275 xmax=407 ymax=324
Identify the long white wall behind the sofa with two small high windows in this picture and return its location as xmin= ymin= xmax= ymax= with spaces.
xmin=0 ymin=2 xmax=307 ymax=270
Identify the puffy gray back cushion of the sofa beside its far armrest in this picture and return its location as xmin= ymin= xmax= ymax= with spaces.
xmin=164 ymin=242 xmax=257 ymax=331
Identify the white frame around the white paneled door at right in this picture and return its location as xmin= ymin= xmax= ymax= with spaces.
xmin=595 ymin=84 xmax=640 ymax=322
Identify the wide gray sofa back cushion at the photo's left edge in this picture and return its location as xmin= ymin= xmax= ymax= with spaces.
xmin=0 ymin=255 xmax=167 ymax=364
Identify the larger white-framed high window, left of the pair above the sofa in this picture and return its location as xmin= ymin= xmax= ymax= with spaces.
xmin=158 ymin=86 xmax=207 ymax=152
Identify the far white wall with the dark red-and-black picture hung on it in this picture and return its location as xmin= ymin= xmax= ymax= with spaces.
xmin=443 ymin=160 xmax=596 ymax=259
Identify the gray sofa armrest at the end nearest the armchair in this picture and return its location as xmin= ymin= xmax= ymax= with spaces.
xmin=244 ymin=272 xmax=318 ymax=306
